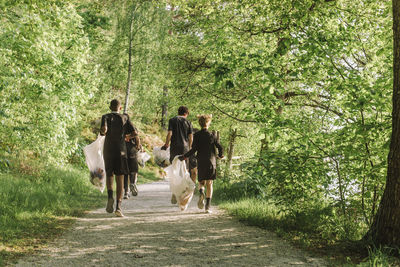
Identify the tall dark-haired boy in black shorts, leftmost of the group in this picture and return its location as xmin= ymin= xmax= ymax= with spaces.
xmin=100 ymin=99 xmax=137 ymax=217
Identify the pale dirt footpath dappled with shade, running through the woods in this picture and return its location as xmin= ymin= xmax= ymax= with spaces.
xmin=16 ymin=182 xmax=326 ymax=267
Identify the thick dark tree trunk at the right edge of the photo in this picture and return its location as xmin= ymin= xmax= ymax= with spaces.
xmin=365 ymin=0 xmax=400 ymax=247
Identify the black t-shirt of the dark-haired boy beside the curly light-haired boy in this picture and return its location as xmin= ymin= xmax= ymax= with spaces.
xmin=168 ymin=116 xmax=193 ymax=149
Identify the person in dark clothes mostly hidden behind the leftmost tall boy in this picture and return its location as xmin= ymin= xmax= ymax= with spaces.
xmin=124 ymin=136 xmax=141 ymax=199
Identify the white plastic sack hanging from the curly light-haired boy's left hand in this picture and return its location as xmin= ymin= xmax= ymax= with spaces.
xmin=164 ymin=156 xmax=196 ymax=211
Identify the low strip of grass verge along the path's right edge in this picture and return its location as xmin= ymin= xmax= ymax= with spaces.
xmin=216 ymin=198 xmax=400 ymax=266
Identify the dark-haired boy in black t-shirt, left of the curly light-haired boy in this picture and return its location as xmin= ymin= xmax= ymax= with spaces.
xmin=161 ymin=106 xmax=193 ymax=204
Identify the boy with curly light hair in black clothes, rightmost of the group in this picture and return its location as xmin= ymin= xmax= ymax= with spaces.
xmin=179 ymin=115 xmax=224 ymax=213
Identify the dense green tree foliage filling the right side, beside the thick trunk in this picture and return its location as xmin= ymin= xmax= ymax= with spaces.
xmin=169 ymin=0 xmax=393 ymax=248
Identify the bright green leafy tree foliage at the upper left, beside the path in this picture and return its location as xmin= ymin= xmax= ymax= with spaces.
xmin=0 ymin=3 xmax=98 ymax=163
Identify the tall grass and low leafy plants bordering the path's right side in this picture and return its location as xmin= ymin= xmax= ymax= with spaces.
xmin=214 ymin=181 xmax=400 ymax=267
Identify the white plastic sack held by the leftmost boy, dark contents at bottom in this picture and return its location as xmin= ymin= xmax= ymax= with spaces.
xmin=83 ymin=135 xmax=106 ymax=193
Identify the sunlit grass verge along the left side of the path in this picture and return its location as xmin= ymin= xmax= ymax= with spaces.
xmin=0 ymin=166 xmax=103 ymax=266
